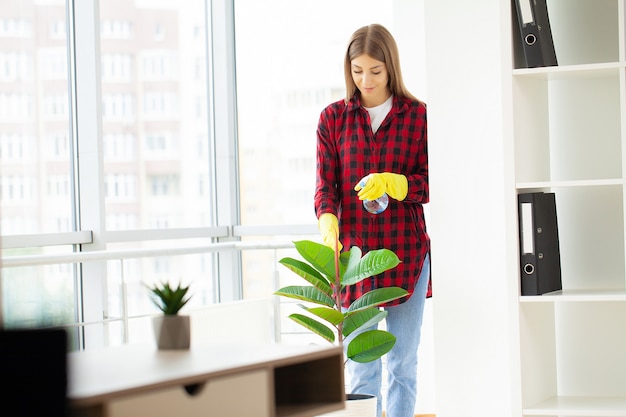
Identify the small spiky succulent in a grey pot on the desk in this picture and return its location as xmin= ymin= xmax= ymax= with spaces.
xmin=148 ymin=282 xmax=191 ymax=350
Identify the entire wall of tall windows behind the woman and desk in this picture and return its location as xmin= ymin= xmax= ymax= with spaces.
xmin=0 ymin=0 xmax=423 ymax=352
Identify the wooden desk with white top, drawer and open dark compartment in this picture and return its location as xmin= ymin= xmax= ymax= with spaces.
xmin=68 ymin=344 xmax=345 ymax=417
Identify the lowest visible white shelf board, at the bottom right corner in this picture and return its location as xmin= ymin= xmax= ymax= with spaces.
xmin=523 ymin=397 xmax=626 ymax=417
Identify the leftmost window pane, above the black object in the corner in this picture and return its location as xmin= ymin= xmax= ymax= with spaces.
xmin=0 ymin=0 xmax=77 ymax=332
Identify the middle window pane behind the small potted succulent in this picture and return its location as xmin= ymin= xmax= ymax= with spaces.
xmin=100 ymin=0 xmax=215 ymax=341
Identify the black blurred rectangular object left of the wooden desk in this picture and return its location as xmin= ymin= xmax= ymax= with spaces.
xmin=0 ymin=329 xmax=68 ymax=417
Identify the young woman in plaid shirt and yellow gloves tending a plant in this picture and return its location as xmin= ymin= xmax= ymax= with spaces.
xmin=315 ymin=24 xmax=430 ymax=417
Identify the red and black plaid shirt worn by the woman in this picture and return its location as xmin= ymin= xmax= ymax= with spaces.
xmin=315 ymin=92 xmax=431 ymax=307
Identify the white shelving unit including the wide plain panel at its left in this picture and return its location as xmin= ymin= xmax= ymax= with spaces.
xmin=424 ymin=0 xmax=626 ymax=417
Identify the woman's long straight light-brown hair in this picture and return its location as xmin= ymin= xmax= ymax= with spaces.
xmin=343 ymin=24 xmax=417 ymax=103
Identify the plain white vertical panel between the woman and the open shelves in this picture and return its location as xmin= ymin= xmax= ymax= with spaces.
xmin=424 ymin=0 xmax=520 ymax=417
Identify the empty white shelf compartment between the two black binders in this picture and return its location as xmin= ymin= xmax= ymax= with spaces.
xmin=513 ymin=70 xmax=624 ymax=182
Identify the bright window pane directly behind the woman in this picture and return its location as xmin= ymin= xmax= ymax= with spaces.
xmin=235 ymin=0 xmax=394 ymax=297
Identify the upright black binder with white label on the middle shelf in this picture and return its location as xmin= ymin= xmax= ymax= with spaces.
xmin=518 ymin=192 xmax=562 ymax=295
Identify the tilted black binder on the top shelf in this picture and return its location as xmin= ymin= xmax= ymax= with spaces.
xmin=513 ymin=0 xmax=558 ymax=68
